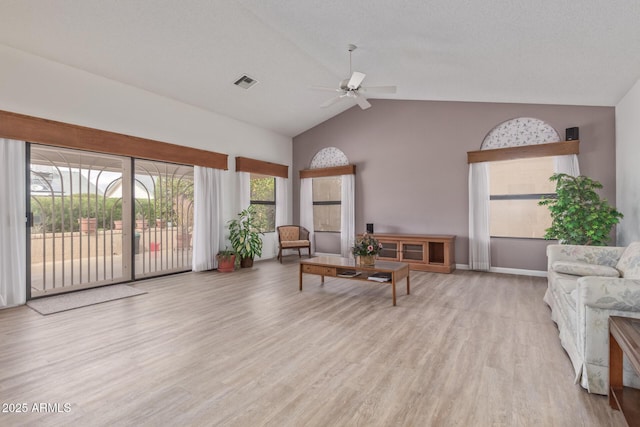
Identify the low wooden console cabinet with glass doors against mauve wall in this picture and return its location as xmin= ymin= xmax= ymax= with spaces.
xmin=364 ymin=233 xmax=456 ymax=273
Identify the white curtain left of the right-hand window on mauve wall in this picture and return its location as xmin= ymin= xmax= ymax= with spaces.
xmin=469 ymin=163 xmax=491 ymax=271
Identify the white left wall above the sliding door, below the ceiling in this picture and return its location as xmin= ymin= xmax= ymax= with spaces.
xmin=0 ymin=45 xmax=292 ymax=258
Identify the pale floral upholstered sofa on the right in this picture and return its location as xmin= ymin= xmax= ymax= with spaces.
xmin=544 ymin=242 xmax=640 ymax=395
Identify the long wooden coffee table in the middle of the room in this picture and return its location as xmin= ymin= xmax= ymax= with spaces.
xmin=300 ymin=256 xmax=411 ymax=305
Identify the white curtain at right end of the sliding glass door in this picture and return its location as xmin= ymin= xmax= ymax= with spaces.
xmin=192 ymin=166 xmax=222 ymax=271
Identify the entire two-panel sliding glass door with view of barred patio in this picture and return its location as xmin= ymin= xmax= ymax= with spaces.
xmin=27 ymin=144 xmax=194 ymax=297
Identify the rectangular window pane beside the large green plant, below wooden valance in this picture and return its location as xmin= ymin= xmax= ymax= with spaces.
xmin=489 ymin=157 xmax=555 ymax=239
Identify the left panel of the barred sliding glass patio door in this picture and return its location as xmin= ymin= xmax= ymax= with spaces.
xmin=27 ymin=144 xmax=130 ymax=297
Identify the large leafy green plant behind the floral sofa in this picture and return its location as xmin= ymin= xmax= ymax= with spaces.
xmin=538 ymin=173 xmax=623 ymax=246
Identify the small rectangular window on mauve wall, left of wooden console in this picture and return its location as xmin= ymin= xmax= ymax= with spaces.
xmin=312 ymin=176 xmax=342 ymax=233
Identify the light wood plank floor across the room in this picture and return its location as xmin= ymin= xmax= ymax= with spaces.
xmin=0 ymin=257 xmax=624 ymax=426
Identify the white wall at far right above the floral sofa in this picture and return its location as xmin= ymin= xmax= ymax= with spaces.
xmin=616 ymin=76 xmax=640 ymax=246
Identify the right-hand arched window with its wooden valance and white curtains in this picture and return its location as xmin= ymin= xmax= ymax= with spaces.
xmin=467 ymin=117 xmax=579 ymax=271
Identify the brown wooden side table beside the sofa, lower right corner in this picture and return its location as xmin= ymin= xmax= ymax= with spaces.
xmin=609 ymin=316 xmax=640 ymax=427
